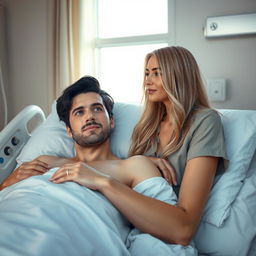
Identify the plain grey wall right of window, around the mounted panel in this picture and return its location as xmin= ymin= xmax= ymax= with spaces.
xmin=176 ymin=0 xmax=256 ymax=109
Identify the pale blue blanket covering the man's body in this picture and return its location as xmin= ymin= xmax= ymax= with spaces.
xmin=0 ymin=168 xmax=196 ymax=256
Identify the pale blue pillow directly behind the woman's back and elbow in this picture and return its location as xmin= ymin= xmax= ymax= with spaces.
xmin=202 ymin=110 xmax=256 ymax=227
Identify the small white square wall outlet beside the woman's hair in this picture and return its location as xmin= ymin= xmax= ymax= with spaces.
xmin=206 ymin=79 xmax=226 ymax=101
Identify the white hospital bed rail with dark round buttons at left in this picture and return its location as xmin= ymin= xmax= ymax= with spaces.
xmin=0 ymin=105 xmax=45 ymax=183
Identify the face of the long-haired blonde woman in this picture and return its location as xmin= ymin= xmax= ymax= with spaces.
xmin=144 ymin=56 xmax=169 ymax=102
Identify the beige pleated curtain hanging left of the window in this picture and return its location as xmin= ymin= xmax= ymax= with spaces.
xmin=51 ymin=0 xmax=80 ymax=98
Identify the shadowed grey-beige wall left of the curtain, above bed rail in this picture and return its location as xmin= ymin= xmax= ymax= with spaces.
xmin=1 ymin=0 xmax=51 ymax=130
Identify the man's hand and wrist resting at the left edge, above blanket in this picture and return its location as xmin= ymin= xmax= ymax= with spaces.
xmin=0 ymin=159 xmax=49 ymax=190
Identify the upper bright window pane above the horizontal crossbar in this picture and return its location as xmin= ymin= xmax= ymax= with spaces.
xmin=98 ymin=0 xmax=168 ymax=38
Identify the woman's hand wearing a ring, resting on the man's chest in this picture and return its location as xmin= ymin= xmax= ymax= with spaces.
xmin=50 ymin=162 xmax=110 ymax=190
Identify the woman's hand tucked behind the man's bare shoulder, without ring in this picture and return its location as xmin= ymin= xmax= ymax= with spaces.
xmin=148 ymin=156 xmax=177 ymax=186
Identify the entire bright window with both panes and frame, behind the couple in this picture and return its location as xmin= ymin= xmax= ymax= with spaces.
xmin=81 ymin=0 xmax=175 ymax=102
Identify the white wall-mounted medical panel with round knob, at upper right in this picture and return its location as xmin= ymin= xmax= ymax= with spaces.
xmin=204 ymin=13 xmax=256 ymax=38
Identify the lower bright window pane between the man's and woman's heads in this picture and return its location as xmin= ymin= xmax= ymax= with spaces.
xmin=99 ymin=43 xmax=167 ymax=103
